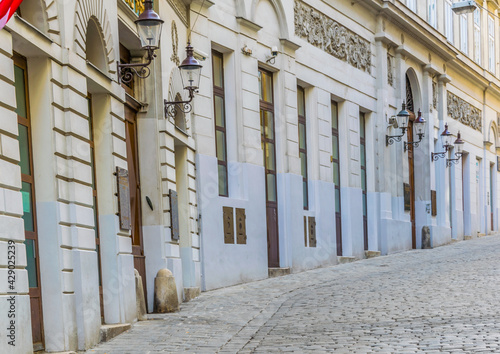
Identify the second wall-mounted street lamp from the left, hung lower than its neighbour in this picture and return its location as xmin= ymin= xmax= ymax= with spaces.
xmin=164 ymin=42 xmax=202 ymax=118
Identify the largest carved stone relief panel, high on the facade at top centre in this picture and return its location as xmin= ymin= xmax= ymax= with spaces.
xmin=295 ymin=0 xmax=372 ymax=73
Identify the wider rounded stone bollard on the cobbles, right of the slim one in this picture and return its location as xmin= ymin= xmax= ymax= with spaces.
xmin=154 ymin=269 xmax=179 ymax=313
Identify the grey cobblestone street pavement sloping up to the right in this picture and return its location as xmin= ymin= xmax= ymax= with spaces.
xmin=88 ymin=236 xmax=500 ymax=354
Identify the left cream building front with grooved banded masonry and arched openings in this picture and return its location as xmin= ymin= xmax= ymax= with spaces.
xmin=0 ymin=0 xmax=201 ymax=353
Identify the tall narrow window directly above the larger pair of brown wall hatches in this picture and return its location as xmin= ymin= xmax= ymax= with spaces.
xmin=212 ymin=50 xmax=229 ymax=197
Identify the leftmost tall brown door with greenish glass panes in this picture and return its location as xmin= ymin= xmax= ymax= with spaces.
xmin=14 ymin=55 xmax=44 ymax=351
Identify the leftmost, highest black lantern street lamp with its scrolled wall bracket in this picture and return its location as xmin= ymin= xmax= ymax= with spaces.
xmin=118 ymin=0 xmax=164 ymax=83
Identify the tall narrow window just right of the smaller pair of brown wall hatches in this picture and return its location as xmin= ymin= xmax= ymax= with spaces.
xmin=332 ymin=101 xmax=342 ymax=256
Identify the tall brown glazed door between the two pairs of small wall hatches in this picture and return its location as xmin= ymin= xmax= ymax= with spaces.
xmin=259 ymin=69 xmax=280 ymax=268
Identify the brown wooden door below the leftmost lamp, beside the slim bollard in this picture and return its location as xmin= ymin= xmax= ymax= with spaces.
xmin=125 ymin=105 xmax=147 ymax=298
